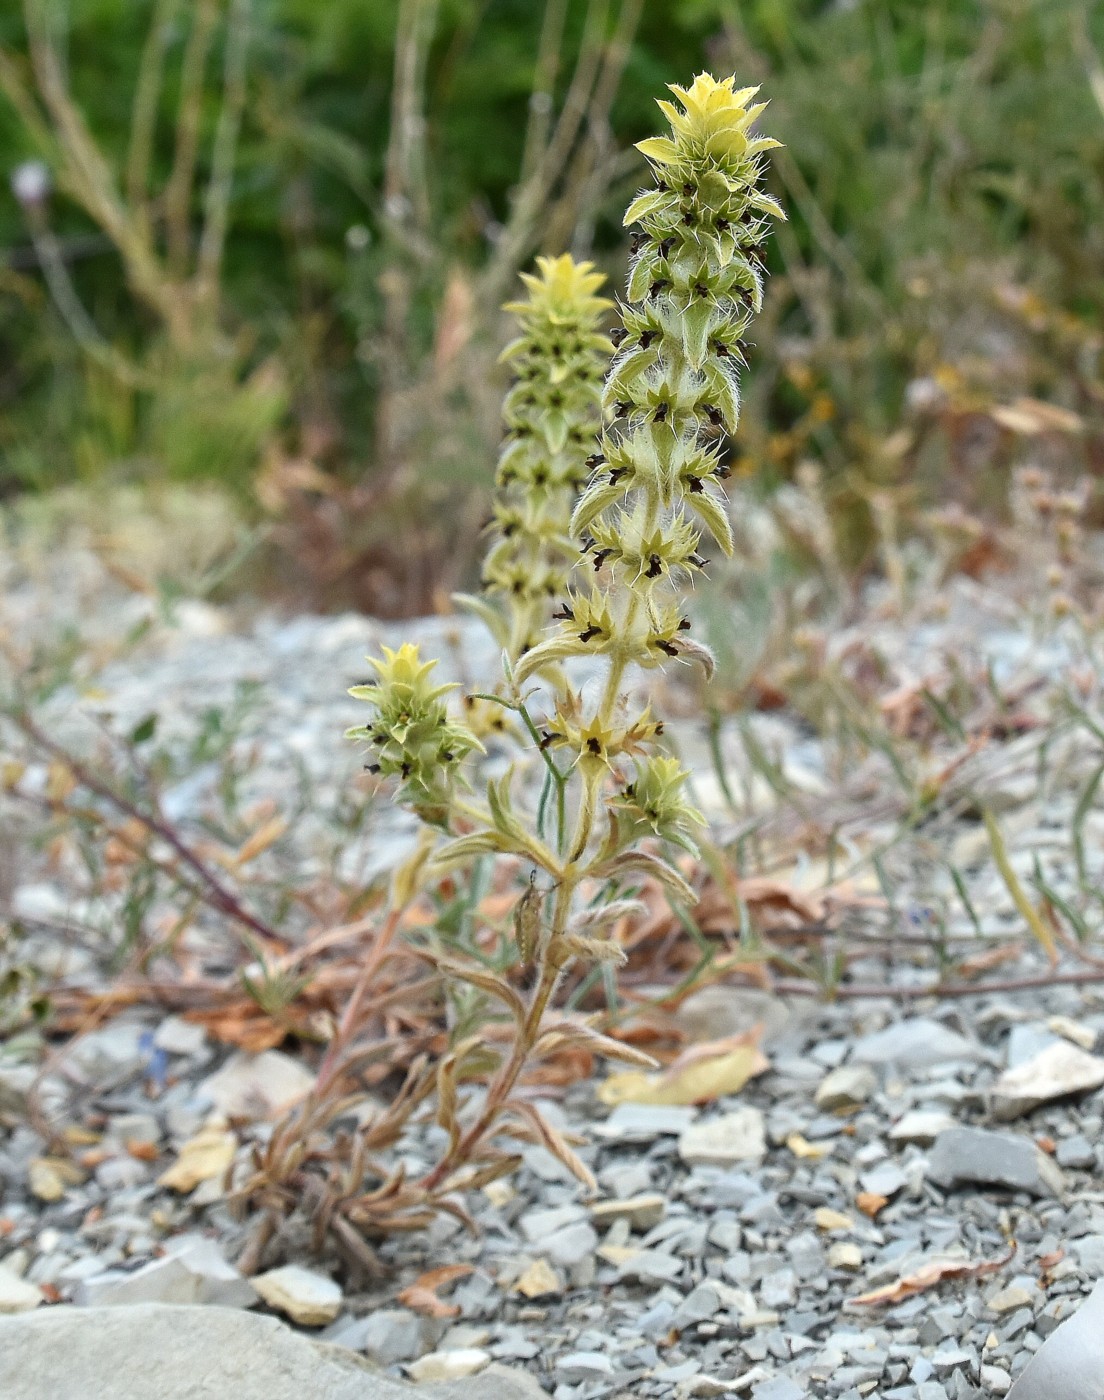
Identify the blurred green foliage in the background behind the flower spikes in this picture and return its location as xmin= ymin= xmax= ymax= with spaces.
xmin=0 ymin=0 xmax=1104 ymax=596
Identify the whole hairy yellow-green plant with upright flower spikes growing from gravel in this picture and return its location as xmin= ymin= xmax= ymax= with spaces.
xmin=239 ymin=74 xmax=782 ymax=1260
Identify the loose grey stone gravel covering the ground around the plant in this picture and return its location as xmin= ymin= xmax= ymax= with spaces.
xmin=0 ymin=529 xmax=1104 ymax=1400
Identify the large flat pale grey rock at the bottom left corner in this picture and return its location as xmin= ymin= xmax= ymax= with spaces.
xmin=0 ymin=1303 xmax=543 ymax=1400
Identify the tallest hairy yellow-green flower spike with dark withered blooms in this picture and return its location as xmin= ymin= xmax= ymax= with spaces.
xmin=519 ymin=74 xmax=782 ymax=679
